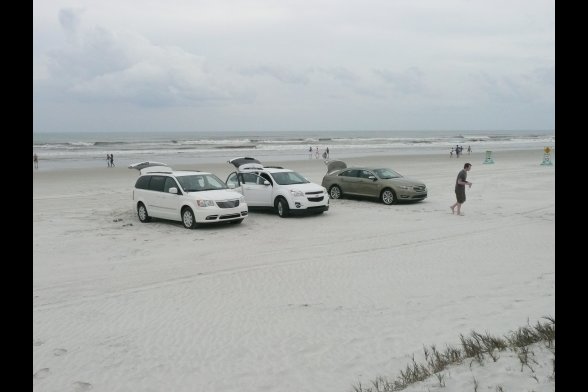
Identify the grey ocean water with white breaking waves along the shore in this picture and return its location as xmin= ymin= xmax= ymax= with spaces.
xmin=33 ymin=130 xmax=555 ymax=170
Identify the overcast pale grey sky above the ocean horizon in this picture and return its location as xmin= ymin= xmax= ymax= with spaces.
xmin=33 ymin=0 xmax=555 ymax=132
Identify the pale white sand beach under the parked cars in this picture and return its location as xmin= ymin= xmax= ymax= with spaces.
xmin=33 ymin=150 xmax=555 ymax=392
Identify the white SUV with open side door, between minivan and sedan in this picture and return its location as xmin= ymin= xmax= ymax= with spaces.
xmin=226 ymin=157 xmax=329 ymax=218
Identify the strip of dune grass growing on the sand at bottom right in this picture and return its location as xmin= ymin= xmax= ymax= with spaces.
xmin=353 ymin=316 xmax=555 ymax=392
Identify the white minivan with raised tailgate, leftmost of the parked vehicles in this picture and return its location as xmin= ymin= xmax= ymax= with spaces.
xmin=129 ymin=162 xmax=248 ymax=229
